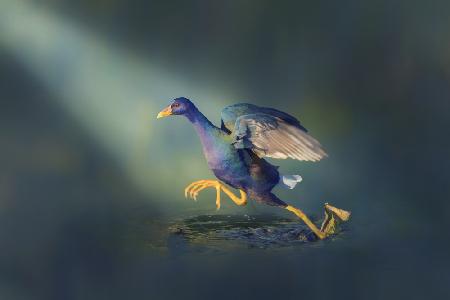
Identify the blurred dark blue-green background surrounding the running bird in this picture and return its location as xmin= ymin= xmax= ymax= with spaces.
xmin=0 ymin=0 xmax=450 ymax=299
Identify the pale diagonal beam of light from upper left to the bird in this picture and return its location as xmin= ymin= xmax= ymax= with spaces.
xmin=0 ymin=0 xmax=239 ymax=211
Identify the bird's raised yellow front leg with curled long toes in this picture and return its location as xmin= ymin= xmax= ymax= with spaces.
xmin=184 ymin=180 xmax=247 ymax=209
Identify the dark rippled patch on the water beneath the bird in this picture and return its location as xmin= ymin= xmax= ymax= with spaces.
xmin=168 ymin=215 xmax=345 ymax=250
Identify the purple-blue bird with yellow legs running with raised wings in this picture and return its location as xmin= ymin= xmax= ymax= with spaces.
xmin=157 ymin=97 xmax=350 ymax=239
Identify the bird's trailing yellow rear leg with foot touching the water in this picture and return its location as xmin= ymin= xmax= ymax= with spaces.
xmin=285 ymin=203 xmax=351 ymax=240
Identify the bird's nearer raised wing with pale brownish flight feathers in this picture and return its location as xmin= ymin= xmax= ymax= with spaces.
xmin=232 ymin=113 xmax=327 ymax=161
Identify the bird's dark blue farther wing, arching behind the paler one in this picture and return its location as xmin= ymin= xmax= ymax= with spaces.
xmin=221 ymin=103 xmax=308 ymax=133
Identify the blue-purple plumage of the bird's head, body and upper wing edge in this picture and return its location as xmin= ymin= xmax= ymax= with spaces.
xmin=158 ymin=98 xmax=326 ymax=206
